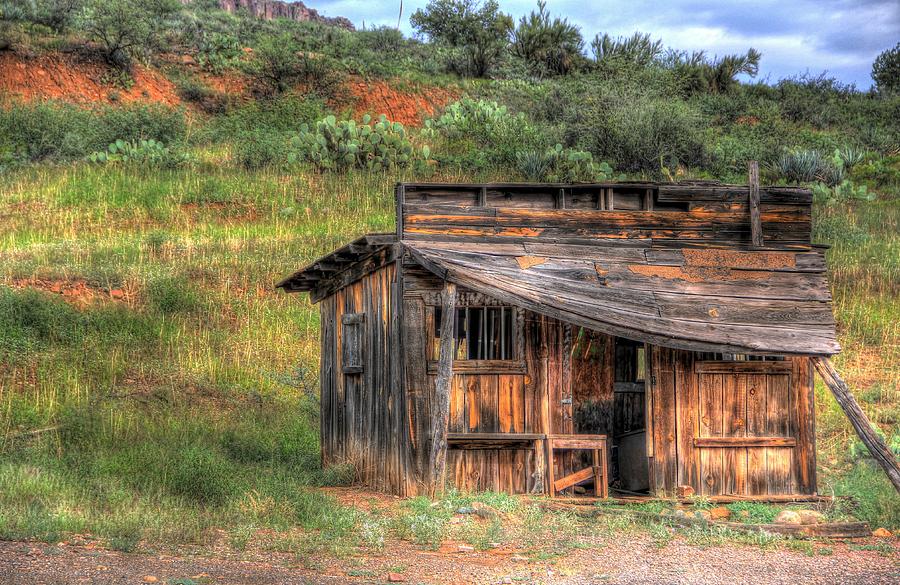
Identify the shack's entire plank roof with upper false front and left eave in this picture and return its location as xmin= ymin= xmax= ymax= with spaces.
xmin=278 ymin=182 xmax=840 ymax=355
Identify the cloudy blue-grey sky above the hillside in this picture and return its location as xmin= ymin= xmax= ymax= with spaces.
xmin=305 ymin=0 xmax=900 ymax=90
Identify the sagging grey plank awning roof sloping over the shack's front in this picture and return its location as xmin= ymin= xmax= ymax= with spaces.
xmin=404 ymin=240 xmax=840 ymax=355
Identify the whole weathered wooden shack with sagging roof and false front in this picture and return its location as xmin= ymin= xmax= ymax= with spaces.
xmin=278 ymin=183 xmax=839 ymax=497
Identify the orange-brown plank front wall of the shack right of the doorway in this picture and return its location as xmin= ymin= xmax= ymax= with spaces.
xmin=651 ymin=347 xmax=816 ymax=496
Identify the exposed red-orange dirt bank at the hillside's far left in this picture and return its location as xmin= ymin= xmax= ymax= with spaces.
xmin=0 ymin=52 xmax=181 ymax=106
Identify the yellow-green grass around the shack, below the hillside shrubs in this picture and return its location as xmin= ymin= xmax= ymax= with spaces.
xmin=0 ymin=143 xmax=900 ymax=562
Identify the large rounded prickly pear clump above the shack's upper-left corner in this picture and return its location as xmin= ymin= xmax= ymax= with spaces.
xmin=288 ymin=115 xmax=430 ymax=171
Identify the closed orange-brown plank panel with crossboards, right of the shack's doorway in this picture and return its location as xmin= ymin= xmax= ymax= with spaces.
xmin=696 ymin=360 xmax=798 ymax=495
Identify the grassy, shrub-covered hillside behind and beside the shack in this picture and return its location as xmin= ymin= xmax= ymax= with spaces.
xmin=0 ymin=0 xmax=900 ymax=549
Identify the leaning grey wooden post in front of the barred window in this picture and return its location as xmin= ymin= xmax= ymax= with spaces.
xmin=429 ymin=282 xmax=456 ymax=496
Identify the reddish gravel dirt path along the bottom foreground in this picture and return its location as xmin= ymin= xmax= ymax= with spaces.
xmin=0 ymin=536 xmax=900 ymax=585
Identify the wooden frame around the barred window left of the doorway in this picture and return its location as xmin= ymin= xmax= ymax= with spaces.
xmin=425 ymin=304 xmax=528 ymax=374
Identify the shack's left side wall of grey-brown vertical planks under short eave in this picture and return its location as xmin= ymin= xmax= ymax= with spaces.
xmin=319 ymin=263 xmax=408 ymax=493
